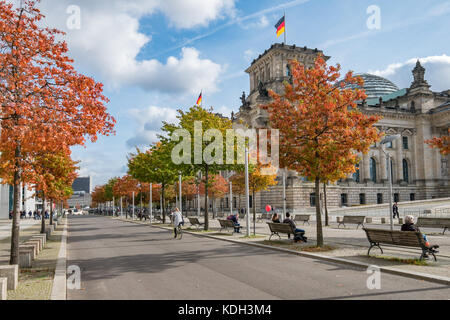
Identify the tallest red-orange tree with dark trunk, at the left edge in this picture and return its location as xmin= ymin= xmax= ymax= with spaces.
xmin=0 ymin=0 xmax=115 ymax=264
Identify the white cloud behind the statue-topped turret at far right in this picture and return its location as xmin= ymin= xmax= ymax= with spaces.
xmin=369 ymin=54 xmax=450 ymax=91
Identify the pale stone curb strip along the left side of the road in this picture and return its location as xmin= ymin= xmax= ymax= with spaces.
xmin=50 ymin=219 xmax=69 ymax=300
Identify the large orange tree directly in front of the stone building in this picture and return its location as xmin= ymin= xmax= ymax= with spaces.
xmin=263 ymin=56 xmax=380 ymax=247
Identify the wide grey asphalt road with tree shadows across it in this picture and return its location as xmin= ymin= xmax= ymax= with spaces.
xmin=67 ymin=216 xmax=450 ymax=300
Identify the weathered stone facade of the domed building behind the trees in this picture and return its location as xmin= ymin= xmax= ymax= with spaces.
xmin=232 ymin=44 xmax=450 ymax=212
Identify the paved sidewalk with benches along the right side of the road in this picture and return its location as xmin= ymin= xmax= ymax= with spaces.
xmin=112 ymin=215 xmax=450 ymax=278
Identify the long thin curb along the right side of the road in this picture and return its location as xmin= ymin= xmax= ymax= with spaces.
xmin=115 ymin=220 xmax=450 ymax=286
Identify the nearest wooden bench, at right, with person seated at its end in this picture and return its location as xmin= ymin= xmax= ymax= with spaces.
xmin=363 ymin=228 xmax=437 ymax=261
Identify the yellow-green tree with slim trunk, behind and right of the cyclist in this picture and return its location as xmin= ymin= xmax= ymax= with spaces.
xmin=161 ymin=106 xmax=232 ymax=230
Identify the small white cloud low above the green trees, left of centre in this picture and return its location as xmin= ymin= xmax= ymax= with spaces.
xmin=127 ymin=106 xmax=178 ymax=148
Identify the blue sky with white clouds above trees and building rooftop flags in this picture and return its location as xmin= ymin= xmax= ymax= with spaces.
xmin=34 ymin=0 xmax=450 ymax=189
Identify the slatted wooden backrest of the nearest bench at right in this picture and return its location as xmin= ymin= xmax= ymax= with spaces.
xmin=363 ymin=228 xmax=425 ymax=248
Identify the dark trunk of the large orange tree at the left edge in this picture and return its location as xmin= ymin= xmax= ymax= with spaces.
xmin=9 ymin=145 xmax=21 ymax=265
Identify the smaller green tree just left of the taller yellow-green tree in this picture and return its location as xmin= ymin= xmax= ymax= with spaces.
xmin=128 ymin=142 xmax=178 ymax=223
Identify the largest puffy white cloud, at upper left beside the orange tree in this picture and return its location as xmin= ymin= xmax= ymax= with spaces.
xmin=31 ymin=0 xmax=230 ymax=93
